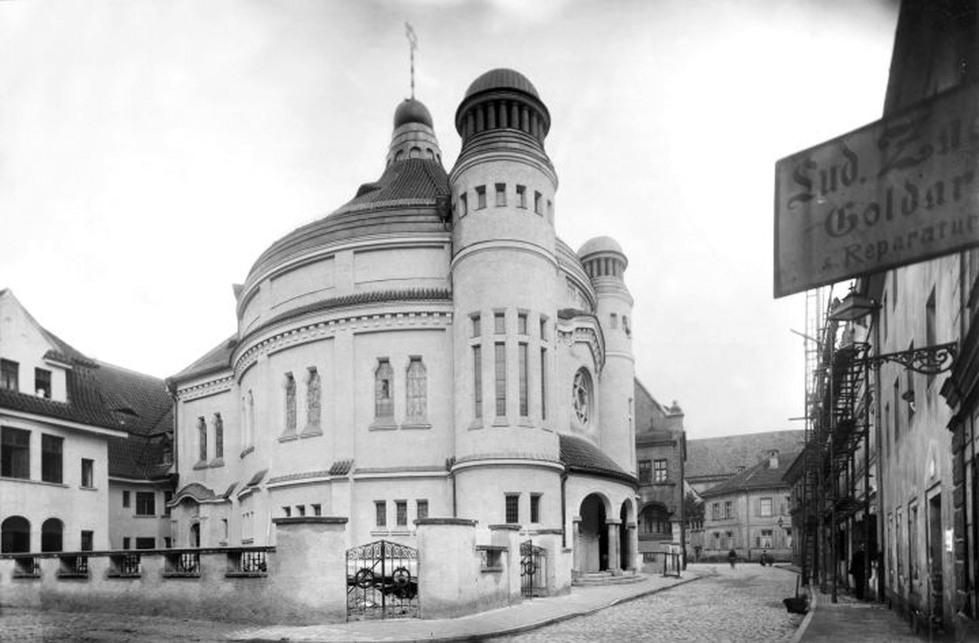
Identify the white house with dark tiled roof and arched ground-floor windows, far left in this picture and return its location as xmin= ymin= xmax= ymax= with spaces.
xmin=0 ymin=290 xmax=172 ymax=553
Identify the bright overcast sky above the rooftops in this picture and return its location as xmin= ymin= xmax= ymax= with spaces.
xmin=0 ymin=0 xmax=897 ymax=439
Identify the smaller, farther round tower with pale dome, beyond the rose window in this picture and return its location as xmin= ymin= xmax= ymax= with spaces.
xmin=578 ymin=237 xmax=636 ymax=475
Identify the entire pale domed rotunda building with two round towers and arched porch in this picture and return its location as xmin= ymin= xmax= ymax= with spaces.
xmin=168 ymin=69 xmax=637 ymax=584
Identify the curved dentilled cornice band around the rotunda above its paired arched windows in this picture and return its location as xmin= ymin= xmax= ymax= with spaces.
xmin=233 ymin=310 xmax=452 ymax=382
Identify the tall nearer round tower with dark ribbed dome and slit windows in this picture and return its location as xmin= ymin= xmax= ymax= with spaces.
xmin=449 ymin=69 xmax=560 ymax=526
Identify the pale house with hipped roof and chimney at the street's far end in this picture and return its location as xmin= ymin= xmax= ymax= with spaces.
xmin=701 ymin=449 xmax=798 ymax=560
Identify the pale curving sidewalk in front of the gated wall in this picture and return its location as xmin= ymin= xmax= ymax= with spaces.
xmin=228 ymin=570 xmax=700 ymax=642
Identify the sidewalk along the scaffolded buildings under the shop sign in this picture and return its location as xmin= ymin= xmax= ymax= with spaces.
xmin=792 ymin=588 xmax=929 ymax=643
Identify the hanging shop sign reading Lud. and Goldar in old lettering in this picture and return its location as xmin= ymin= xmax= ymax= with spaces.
xmin=775 ymin=85 xmax=979 ymax=297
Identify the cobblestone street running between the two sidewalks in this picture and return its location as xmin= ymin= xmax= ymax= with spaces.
xmin=493 ymin=564 xmax=803 ymax=643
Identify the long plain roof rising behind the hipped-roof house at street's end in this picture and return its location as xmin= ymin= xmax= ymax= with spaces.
xmin=684 ymin=431 xmax=805 ymax=480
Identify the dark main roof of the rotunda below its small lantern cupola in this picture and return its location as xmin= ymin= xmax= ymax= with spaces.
xmin=248 ymin=159 xmax=449 ymax=280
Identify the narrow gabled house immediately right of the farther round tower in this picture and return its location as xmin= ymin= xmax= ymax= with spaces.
xmin=636 ymin=380 xmax=686 ymax=552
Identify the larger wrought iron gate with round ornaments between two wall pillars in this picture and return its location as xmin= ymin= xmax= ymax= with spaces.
xmin=347 ymin=540 xmax=418 ymax=621
